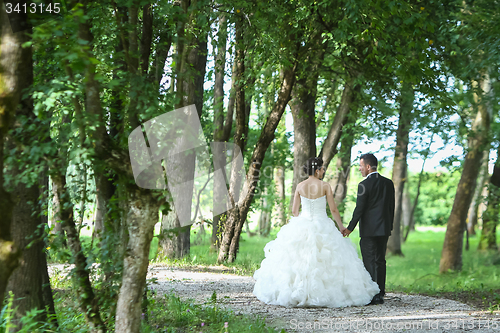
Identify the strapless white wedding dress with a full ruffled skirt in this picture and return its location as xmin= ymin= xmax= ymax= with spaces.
xmin=253 ymin=196 xmax=379 ymax=307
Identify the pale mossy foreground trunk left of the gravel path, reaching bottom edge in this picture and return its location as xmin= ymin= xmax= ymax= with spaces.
xmin=115 ymin=189 xmax=160 ymax=333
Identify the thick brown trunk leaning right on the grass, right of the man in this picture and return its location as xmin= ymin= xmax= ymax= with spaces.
xmin=439 ymin=75 xmax=491 ymax=273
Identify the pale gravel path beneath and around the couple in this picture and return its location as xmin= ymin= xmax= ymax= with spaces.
xmin=148 ymin=264 xmax=500 ymax=332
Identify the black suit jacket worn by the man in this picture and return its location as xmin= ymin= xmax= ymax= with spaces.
xmin=347 ymin=172 xmax=395 ymax=237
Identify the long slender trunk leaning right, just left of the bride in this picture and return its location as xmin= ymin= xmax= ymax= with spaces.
xmin=217 ymin=64 xmax=297 ymax=262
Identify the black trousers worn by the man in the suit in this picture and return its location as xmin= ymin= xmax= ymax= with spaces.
xmin=359 ymin=236 xmax=389 ymax=296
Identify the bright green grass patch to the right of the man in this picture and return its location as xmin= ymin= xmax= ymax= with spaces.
xmin=387 ymin=227 xmax=500 ymax=311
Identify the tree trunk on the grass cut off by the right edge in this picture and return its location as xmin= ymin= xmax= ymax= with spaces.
xmin=477 ymin=147 xmax=500 ymax=250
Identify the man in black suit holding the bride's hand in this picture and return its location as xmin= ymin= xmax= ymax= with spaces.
xmin=343 ymin=154 xmax=395 ymax=305
